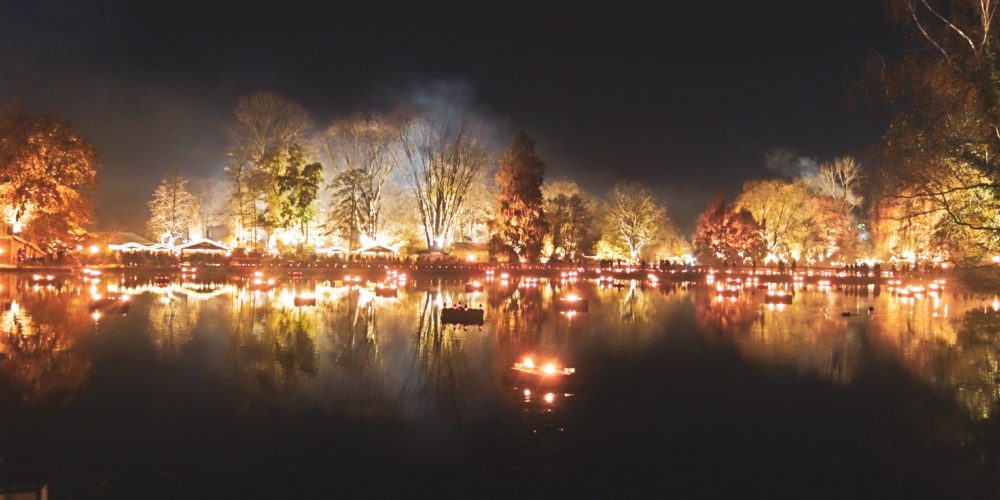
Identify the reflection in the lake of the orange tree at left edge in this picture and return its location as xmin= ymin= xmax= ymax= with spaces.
xmin=0 ymin=292 xmax=92 ymax=404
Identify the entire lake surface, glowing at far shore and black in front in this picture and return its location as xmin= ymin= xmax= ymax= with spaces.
xmin=0 ymin=275 xmax=1000 ymax=498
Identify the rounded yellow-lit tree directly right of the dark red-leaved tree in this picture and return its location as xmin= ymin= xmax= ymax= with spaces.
xmin=734 ymin=179 xmax=813 ymax=259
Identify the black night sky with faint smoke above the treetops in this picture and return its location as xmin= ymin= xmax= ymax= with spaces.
xmin=0 ymin=0 xmax=893 ymax=230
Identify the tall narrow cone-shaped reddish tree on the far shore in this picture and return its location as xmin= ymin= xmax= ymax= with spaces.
xmin=493 ymin=132 xmax=546 ymax=259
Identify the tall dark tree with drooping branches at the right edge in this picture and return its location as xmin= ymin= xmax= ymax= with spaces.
xmin=879 ymin=0 xmax=1000 ymax=255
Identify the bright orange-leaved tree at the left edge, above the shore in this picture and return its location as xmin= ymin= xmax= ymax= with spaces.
xmin=0 ymin=106 xmax=97 ymax=249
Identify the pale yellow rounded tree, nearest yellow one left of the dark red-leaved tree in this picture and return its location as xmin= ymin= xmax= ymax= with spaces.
xmin=605 ymin=182 xmax=667 ymax=259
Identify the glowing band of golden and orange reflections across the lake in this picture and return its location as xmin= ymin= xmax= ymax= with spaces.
xmin=0 ymin=275 xmax=1000 ymax=421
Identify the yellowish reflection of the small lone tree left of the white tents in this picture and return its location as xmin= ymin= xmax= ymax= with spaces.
xmin=149 ymin=295 xmax=200 ymax=361
